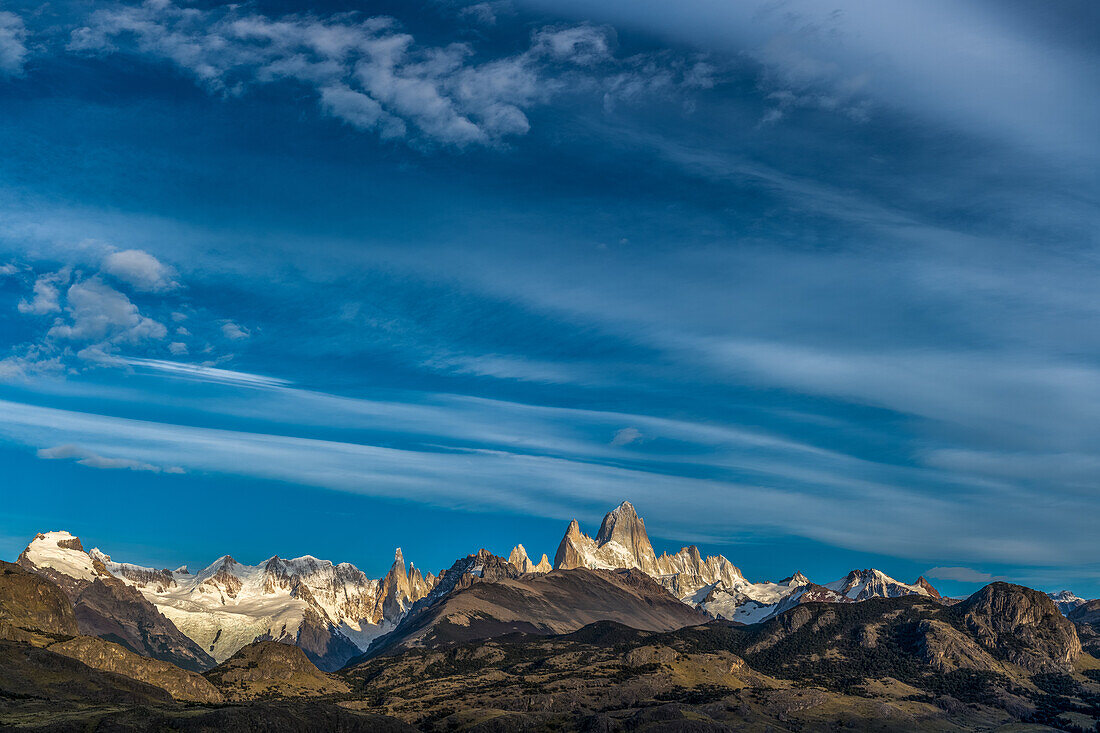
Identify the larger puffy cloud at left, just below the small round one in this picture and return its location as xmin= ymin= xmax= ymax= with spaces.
xmin=47 ymin=277 xmax=167 ymax=351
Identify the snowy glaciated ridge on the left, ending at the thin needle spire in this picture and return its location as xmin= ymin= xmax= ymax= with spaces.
xmin=19 ymin=532 xmax=437 ymax=669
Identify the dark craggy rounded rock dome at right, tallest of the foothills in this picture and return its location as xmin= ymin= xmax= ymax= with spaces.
xmin=945 ymin=582 xmax=1081 ymax=671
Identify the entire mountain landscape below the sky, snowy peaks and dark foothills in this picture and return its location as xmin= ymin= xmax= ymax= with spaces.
xmin=0 ymin=502 xmax=1100 ymax=731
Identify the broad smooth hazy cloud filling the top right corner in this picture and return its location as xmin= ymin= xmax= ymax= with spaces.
xmin=528 ymin=0 xmax=1100 ymax=166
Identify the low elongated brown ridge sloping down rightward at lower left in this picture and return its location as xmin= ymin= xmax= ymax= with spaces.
xmin=48 ymin=636 xmax=222 ymax=702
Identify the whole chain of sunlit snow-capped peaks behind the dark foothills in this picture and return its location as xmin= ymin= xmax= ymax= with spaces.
xmin=18 ymin=502 xmax=1084 ymax=670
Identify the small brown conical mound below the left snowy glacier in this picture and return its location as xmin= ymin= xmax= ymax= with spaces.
xmin=206 ymin=642 xmax=348 ymax=700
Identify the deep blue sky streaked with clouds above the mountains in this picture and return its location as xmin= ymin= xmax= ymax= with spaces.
xmin=0 ymin=0 xmax=1100 ymax=598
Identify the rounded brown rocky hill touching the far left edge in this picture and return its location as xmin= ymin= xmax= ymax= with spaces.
xmin=0 ymin=560 xmax=79 ymax=646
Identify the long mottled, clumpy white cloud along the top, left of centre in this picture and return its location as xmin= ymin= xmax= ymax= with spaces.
xmin=68 ymin=0 xmax=692 ymax=147
